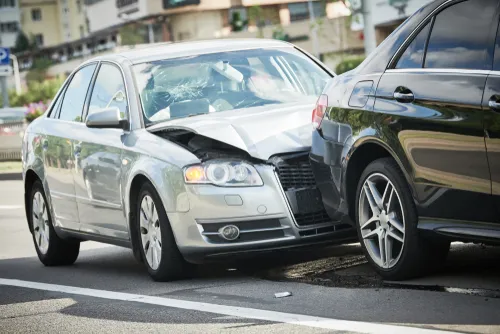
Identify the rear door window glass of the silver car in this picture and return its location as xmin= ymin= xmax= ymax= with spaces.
xmin=59 ymin=64 xmax=96 ymax=122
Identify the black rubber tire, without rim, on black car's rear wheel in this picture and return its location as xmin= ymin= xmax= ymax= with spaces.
xmin=354 ymin=158 xmax=450 ymax=281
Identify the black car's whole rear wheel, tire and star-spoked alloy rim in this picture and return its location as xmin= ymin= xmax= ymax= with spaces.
xmin=355 ymin=158 xmax=450 ymax=281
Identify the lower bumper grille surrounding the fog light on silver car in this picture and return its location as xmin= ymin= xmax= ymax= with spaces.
xmin=199 ymin=219 xmax=289 ymax=244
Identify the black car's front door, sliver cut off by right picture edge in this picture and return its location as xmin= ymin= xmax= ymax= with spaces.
xmin=483 ymin=14 xmax=500 ymax=222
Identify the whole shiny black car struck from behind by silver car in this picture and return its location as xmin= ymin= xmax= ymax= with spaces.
xmin=310 ymin=0 xmax=500 ymax=280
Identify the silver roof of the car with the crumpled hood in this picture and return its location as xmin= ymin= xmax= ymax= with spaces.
xmin=87 ymin=38 xmax=294 ymax=64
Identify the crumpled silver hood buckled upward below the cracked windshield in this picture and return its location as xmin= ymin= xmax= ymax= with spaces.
xmin=148 ymin=100 xmax=314 ymax=160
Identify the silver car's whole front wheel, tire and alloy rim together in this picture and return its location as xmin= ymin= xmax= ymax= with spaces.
xmin=135 ymin=183 xmax=188 ymax=282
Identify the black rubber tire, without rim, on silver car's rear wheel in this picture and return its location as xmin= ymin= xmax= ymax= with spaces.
xmin=27 ymin=181 xmax=80 ymax=266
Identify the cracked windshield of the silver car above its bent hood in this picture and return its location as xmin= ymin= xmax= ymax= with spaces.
xmin=134 ymin=48 xmax=330 ymax=125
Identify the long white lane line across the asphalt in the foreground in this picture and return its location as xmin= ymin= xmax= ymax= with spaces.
xmin=0 ymin=278 xmax=458 ymax=334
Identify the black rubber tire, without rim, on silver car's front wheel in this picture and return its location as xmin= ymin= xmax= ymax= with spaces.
xmin=135 ymin=183 xmax=189 ymax=282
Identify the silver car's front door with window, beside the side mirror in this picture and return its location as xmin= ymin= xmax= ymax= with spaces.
xmin=75 ymin=62 xmax=128 ymax=239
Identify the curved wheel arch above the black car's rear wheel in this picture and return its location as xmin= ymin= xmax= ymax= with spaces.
xmin=344 ymin=138 xmax=415 ymax=222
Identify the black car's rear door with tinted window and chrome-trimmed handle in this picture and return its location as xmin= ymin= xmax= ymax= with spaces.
xmin=375 ymin=0 xmax=498 ymax=222
